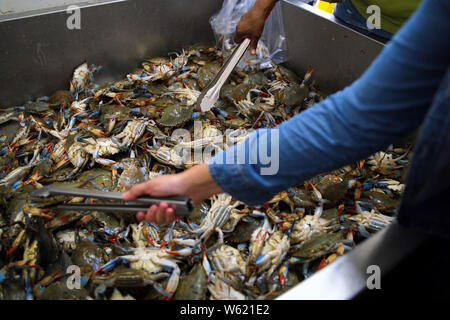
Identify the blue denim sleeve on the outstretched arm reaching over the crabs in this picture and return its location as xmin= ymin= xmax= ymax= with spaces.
xmin=209 ymin=0 xmax=450 ymax=205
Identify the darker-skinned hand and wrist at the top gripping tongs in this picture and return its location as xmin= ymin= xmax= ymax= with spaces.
xmin=235 ymin=0 xmax=278 ymax=54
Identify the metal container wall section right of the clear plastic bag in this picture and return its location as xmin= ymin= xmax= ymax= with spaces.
xmin=282 ymin=0 xmax=384 ymax=94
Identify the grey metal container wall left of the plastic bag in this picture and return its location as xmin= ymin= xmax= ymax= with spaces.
xmin=0 ymin=0 xmax=221 ymax=107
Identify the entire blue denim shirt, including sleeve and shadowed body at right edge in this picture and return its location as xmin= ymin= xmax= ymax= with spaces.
xmin=209 ymin=0 xmax=450 ymax=236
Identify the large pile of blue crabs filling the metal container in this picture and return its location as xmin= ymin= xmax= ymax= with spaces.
xmin=0 ymin=45 xmax=410 ymax=299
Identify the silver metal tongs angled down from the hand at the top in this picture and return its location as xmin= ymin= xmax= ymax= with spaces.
xmin=197 ymin=38 xmax=250 ymax=112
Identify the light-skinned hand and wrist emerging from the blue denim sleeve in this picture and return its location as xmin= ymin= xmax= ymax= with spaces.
xmin=123 ymin=163 xmax=223 ymax=224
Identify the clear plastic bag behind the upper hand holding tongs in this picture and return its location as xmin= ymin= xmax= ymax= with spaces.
xmin=210 ymin=0 xmax=286 ymax=70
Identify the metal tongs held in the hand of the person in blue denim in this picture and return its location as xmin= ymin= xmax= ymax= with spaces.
xmin=31 ymin=186 xmax=194 ymax=217
